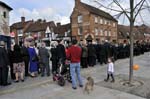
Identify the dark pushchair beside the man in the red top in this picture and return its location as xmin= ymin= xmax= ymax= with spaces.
xmin=53 ymin=61 xmax=71 ymax=86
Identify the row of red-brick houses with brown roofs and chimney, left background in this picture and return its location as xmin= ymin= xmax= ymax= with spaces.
xmin=10 ymin=17 xmax=56 ymax=45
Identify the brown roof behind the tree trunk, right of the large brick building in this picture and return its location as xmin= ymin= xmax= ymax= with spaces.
xmin=118 ymin=25 xmax=144 ymax=39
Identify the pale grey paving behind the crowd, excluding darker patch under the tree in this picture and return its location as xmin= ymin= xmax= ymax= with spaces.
xmin=0 ymin=53 xmax=150 ymax=99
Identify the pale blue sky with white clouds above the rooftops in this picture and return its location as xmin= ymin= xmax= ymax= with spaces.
xmin=1 ymin=0 xmax=150 ymax=25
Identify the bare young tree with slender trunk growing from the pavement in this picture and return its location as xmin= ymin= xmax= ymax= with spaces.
xmin=92 ymin=0 xmax=150 ymax=84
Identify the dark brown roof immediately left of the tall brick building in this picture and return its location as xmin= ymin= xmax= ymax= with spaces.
xmin=54 ymin=23 xmax=71 ymax=37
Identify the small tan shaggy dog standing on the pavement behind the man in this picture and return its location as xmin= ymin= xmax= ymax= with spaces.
xmin=84 ymin=77 xmax=94 ymax=94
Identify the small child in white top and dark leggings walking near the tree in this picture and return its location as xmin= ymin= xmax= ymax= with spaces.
xmin=104 ymin=58 xmax=115 ymax=82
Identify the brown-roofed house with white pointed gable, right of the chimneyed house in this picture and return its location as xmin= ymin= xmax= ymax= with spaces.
xmin=24 ymin=19 xmax=56 ymax=42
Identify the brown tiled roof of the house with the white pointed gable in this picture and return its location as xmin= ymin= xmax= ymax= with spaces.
xmin=24 ymin=21 xmax=56 ymax=33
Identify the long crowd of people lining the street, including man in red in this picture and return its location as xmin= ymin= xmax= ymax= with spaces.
xmin=0 ymin=40 xmax=150 ymax=89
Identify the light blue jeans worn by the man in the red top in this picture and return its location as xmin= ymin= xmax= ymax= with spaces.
xmin=70 ymin=63 xmax=83 ymax=88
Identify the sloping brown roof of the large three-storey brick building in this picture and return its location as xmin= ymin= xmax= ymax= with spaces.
xmin=81 ymin=2 xmax=118 ymax=22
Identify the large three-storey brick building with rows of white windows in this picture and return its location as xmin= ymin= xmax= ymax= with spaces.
xmin=70 ymin=0 xmax=118 ymax=40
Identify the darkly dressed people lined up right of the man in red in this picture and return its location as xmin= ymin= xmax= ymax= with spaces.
xmin=80 ymin=40 xmax=150 ymax=68
